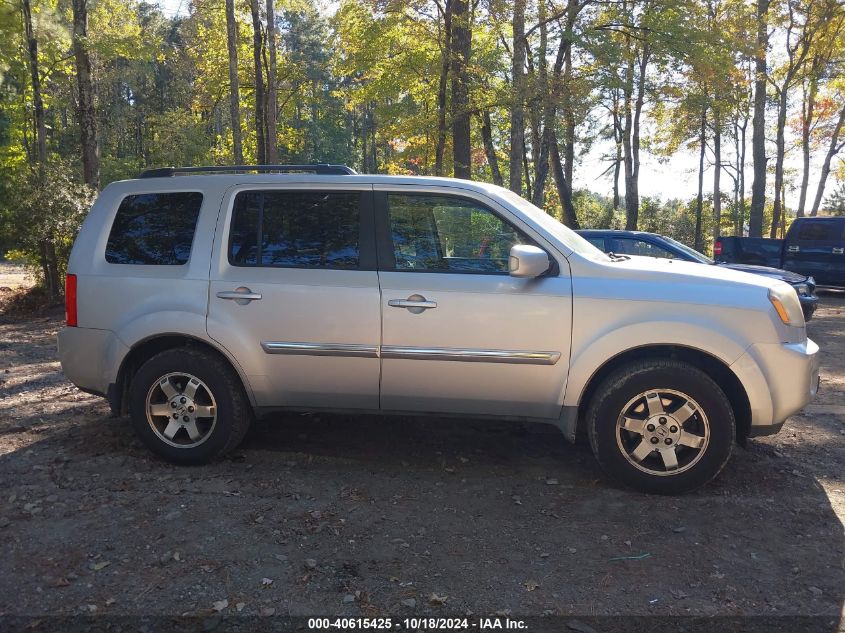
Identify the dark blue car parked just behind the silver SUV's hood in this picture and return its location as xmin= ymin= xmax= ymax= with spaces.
xmin=577 ymin=229 xmax=819 ymax=321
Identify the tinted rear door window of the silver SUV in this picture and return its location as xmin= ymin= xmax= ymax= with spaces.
xmin=229 ymin=190 xmax=362 ymax=269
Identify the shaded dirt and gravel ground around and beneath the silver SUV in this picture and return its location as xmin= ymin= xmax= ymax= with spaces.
xmin=0 ymin=264 xmax=845 ymax=630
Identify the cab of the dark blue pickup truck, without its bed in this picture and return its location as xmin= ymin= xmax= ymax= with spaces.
xmin=783 ymin=218 xmax=845 ymax=285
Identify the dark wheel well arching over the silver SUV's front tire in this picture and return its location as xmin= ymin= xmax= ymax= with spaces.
xmin=578 ymin=345 xmax=751 ymax=443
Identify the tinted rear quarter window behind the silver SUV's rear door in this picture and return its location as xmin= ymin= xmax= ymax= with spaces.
xmin=106 ymin=191 xmax=202 ymax=266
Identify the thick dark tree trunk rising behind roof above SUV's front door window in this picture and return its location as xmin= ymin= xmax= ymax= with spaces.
xmin=452 ymin=0 xmax=472 ymax=179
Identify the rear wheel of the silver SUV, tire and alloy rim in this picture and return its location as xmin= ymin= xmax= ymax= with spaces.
xmin=129 ymin=348 xmax=252 ymax=464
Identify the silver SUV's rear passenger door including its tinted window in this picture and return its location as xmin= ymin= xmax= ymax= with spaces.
xmin=207 ymin=182 xmax=381 ymax=409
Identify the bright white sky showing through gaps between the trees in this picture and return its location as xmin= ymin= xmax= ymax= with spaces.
xmin=152 ymin=0 xmax=834 ymax=209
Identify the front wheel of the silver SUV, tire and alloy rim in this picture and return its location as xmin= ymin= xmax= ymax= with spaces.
xmin=587 ymin=359 xmax=736 ymax=494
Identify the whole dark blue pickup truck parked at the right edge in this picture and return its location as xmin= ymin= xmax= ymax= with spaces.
xmin=713 ymin=217 xmax=845 ymax=288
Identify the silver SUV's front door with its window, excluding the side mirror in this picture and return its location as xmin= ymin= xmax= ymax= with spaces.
xmin=376 ymin=185 xmax=572 ymax=419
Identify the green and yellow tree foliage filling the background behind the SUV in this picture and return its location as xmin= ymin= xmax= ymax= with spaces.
xmin=0 ymin=0 xmax=845 ymax=286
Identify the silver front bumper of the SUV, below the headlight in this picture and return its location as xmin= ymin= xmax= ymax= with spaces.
xmin=733 ymin=339 xmax=819 ymax=437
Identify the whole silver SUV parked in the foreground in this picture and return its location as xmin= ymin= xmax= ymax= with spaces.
xmin=59 ymin=165 xmax=818 ymax=493
